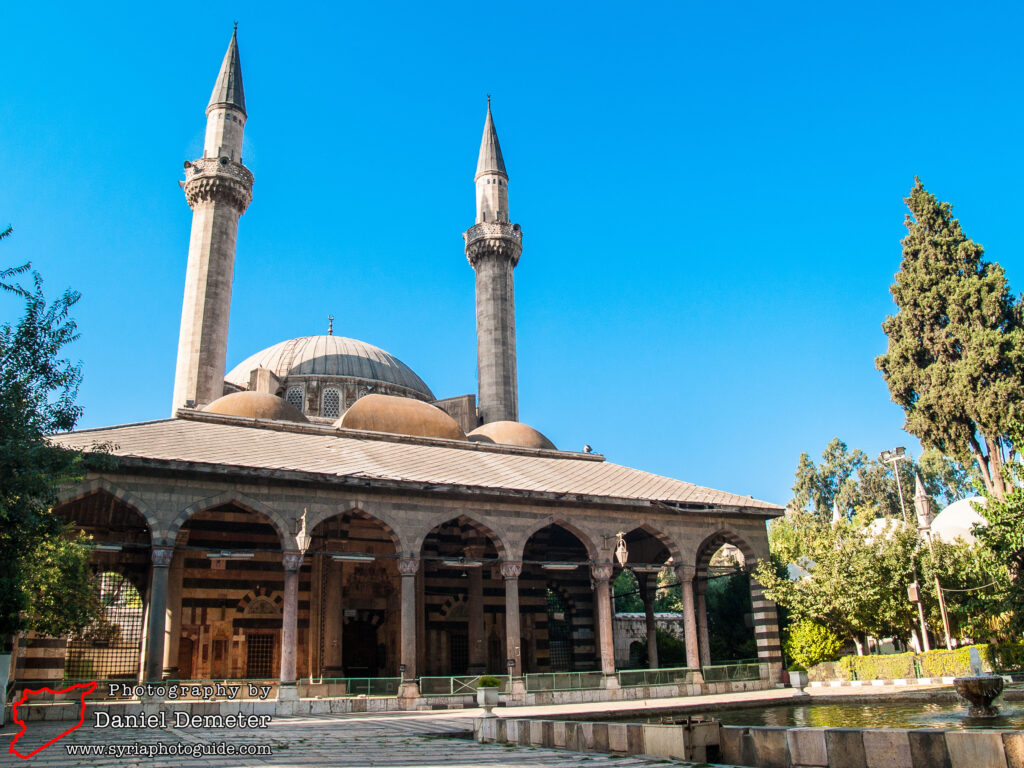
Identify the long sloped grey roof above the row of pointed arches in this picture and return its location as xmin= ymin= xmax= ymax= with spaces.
xmin=50 ymin=411 xmax=782 ymax=517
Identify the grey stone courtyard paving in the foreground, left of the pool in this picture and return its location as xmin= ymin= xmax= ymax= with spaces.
xmin=0 ymin=711 xmax=720 ymax=768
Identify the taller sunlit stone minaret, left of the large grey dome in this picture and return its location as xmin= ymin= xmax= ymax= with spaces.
xmin=171 ymin=26 xmax=253 ymax=413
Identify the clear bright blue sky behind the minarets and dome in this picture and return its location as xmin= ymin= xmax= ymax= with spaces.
xmin=0 ymin=2 xmax=1024 ymax=504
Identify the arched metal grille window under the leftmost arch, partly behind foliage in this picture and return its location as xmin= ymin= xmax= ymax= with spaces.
xmin=65 ymin=571 xmax=142 ymax=680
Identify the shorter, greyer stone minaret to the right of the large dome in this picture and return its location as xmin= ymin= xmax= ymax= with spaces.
xmin=463 ymin=96 xmax=522 ymax=424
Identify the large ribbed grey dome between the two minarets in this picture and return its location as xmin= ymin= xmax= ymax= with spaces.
xmin=224 ymin=336 xmax=436 ymax=400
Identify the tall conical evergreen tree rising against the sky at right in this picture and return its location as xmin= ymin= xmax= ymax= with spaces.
xmin=876 ymin=179 xmax=1024 ymax=499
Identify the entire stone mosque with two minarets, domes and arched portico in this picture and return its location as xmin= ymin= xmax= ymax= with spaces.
xmin=15 ymin=30 xmax=782 ymax=698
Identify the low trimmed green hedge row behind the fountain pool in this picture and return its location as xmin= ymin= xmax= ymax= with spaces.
xmin=807 ymin=643 xmax=1024 ymax=682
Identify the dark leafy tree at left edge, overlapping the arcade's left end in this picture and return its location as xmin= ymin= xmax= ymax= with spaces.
xmin=0 ymin=250 xmax=98 ymax=651
